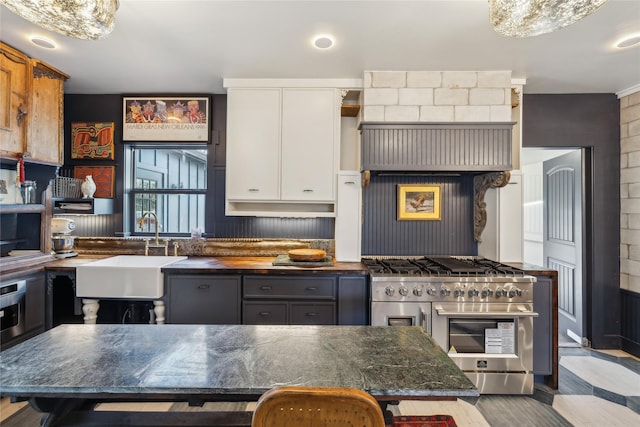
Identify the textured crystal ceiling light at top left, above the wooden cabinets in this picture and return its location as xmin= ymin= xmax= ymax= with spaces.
xmin=0 ymin=0 xmax=119 ymax=40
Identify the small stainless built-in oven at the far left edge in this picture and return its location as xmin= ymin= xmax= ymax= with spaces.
xmin=0 ymin=280 xmax=27 ymax=342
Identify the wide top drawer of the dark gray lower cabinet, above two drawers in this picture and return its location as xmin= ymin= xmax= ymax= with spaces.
xmin=243 ymin=276 xmax=336 ymax=300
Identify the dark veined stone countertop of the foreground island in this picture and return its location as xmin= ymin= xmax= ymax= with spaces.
xmin=0 ymin=324 xmax=478 ymax=401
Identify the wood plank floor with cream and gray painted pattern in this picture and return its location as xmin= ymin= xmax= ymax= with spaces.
xmin=0 ymin=347 xmax=640 ymax=427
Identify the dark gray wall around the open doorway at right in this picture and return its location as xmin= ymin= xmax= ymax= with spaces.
xmin=522 ymin=94 xmax=620 ymax=348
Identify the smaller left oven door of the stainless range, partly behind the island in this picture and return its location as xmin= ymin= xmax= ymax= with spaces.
xmin=371 ymin=301 xmax=431 ymax=333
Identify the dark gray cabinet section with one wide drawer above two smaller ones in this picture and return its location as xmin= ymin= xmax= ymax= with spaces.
xmin=242 ymin=275 xmax=337 ymax=325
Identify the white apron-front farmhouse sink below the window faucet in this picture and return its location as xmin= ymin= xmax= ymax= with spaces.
xmin=76 ymin=255 xmax=187 ymax=299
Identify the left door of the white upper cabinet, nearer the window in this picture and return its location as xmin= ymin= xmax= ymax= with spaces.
xmin=226 ymin=88 xmax=282 ymax=201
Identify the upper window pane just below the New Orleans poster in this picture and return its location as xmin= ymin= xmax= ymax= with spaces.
xmin=133 ymin=148 xmax=207 ymax=190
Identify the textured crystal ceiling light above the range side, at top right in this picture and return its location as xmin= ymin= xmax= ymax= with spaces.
xmin=489 ymin=0 xmax=607 ymax=37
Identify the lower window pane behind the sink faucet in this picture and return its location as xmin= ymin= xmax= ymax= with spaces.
xmin=134 ymin=193 xmax=205 ymax=233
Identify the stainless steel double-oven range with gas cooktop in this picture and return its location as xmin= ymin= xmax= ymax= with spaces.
xmin=362 ymin=257 xmax=538 ymax=394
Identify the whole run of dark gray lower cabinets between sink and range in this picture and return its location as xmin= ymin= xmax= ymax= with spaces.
xmin=165 ymin=273 xmax=369 ymax=325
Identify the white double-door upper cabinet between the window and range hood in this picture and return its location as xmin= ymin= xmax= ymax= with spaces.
xmin=225 ymin=79 xmax=360 ymax=217
